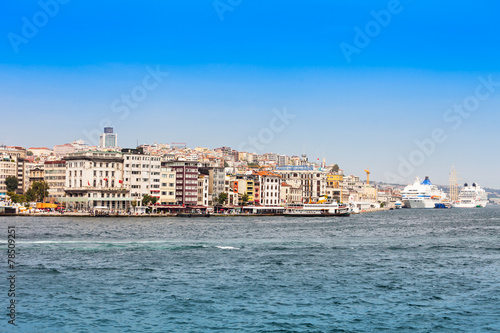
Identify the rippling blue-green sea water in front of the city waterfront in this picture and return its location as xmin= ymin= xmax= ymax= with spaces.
xmin=0 ymin=206 xmax=500 ymax=332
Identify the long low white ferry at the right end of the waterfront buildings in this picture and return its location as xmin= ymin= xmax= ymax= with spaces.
xmin=283 ymin=202 xmax=351 ymax=217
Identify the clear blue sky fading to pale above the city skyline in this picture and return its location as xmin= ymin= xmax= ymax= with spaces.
xmin=0 ymin=0 xmax=500 ymax=188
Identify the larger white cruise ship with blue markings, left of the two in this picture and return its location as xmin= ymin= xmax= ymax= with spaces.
xmin=401 ymin=177 xmax=446 ymax=208
